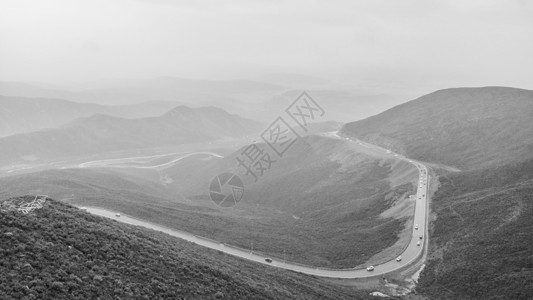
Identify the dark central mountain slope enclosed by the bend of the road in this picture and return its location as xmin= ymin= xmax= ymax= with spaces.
xmin=104 ymin=136 xmax=417 ymax=267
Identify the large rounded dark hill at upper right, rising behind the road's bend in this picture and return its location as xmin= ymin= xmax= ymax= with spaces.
xmin=342 ymin=87 xmax=533 ymax=169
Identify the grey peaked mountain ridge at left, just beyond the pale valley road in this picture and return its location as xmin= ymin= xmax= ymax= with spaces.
xmin=0 ymin=106 xmax=261 ymax=164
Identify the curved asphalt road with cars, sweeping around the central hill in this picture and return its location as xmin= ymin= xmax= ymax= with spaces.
xmin=82 ymin=132 xmax=428 ymax=278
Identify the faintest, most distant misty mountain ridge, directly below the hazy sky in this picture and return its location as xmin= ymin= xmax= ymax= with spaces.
xmin=0 ymin=78 xmax=402 ymax=123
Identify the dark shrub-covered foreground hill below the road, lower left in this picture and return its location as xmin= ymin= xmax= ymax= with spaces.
xmin=0 ymin=200 xmax=369 ymax=300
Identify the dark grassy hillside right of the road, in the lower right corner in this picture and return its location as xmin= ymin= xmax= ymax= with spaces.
xmin=417 ymin=160 xmax=533 ymax=299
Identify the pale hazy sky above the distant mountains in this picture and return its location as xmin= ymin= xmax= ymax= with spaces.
xmin=0 ymin=0 xmax=533 ymax=93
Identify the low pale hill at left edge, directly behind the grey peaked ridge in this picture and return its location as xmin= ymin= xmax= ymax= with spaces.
xmin=0 ymin=96 xmax=178 ymax=137
